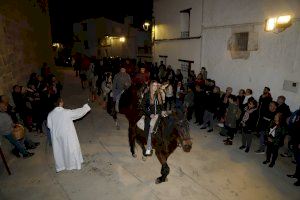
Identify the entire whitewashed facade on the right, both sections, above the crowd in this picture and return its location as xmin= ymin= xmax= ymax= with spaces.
xmin=152 ymin=0 xmax=300 ymax=110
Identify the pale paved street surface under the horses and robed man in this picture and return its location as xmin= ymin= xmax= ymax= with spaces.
xmin=0 ymin=69 xmax=300 ymax=200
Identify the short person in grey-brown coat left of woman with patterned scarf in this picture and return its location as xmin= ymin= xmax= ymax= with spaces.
xmin=224 ymin=95 xmax=241 ymax=145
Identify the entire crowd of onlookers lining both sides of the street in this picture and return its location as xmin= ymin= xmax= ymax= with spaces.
xmin=0 ymin=55 xmax=300 ymax=186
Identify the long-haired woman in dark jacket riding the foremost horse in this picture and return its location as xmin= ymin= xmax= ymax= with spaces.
xmin=141 ymin=81 xmax=163 ymax=155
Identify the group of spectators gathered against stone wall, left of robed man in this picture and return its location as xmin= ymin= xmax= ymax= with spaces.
xmin=0 ymin=63 xmax=62 ymax=158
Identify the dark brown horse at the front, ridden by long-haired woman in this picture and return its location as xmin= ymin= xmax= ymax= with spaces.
xmin=119 ymin=86 xmax=192 ymax=184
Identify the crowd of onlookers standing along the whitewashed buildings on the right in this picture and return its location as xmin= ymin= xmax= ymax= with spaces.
xmin=76 ymin=56 xmax=300 ymax=186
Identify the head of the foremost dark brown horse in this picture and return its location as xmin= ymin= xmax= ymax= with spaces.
xmin=176 ymin=111 xmax=193 ymax=152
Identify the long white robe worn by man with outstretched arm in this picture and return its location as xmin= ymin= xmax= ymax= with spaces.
xmin=47 ymin=104 xmax=91 ymax=172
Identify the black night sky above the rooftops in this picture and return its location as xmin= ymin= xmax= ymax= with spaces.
xmin=49 ymin=0 xmax=153 ymax=43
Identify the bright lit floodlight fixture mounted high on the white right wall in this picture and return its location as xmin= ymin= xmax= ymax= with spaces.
xmin=265 ymin=15 xmax=292 ymax=33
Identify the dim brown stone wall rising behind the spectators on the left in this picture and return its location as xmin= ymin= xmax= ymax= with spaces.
xmin=0 ymin=0 xmax=53 ymax=95
